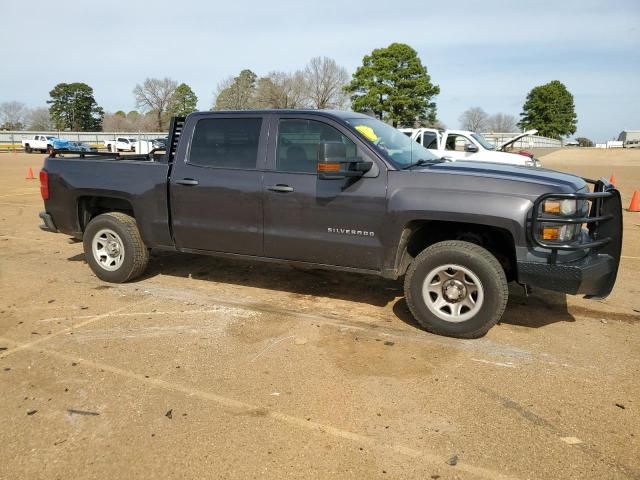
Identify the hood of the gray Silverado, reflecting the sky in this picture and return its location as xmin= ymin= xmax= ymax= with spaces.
xmin=412 ymin=160 xmax=586 ymax=193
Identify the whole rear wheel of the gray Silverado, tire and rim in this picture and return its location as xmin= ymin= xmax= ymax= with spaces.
xmin=83 ymin=212 xmax=149 ymax=283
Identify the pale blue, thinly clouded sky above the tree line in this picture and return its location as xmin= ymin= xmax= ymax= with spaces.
xmin=0 ymin=0 xmax=640 ymax=141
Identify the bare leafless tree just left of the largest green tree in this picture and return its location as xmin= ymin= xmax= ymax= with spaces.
xmin=303 ymin=57 xmax=349 ymax=109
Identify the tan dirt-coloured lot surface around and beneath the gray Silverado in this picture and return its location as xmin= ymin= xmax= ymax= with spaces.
xmin=0 ymin=149 xmax=640 ymax=479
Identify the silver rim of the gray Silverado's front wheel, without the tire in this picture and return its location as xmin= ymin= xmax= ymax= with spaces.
xmin=422 ymin=264 xmax=484 ymax=323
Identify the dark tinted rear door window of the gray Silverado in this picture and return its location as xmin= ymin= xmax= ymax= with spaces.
xmin=189 ymin=118 xmax=262 ymax=169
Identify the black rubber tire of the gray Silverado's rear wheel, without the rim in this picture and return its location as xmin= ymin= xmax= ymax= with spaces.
xmin=83 ymin=212 xmax=149 ymax=283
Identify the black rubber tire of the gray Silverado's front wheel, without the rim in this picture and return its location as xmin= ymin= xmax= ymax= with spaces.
xmin=404 ymin=240 xmax=509 ymax=338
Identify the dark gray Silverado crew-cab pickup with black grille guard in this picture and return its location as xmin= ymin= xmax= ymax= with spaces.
xmin=40 ymin=110 xmax=622 ymax=338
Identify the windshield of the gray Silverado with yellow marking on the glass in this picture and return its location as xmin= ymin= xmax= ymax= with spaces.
xmin=346 ymin=118 xmax=438 ymax=168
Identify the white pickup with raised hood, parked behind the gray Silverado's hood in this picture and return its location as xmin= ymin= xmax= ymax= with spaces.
xmin=400 ymin=128 xmax=542 ymax=167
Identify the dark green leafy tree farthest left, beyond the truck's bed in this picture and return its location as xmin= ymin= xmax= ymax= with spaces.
xmin=47 ymin=82 xmax=104 ymax=131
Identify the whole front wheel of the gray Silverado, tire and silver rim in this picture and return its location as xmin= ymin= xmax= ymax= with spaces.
xmin=404 ymin=240 xmax=509 ymax=338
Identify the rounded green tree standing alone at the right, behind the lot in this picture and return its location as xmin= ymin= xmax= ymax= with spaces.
xmin=518 ymin=80 xmax=578 ymax=139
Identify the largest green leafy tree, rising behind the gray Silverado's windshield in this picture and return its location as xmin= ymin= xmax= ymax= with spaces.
xmin=345 ymin=43 xmax=440 ymax=127
